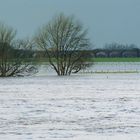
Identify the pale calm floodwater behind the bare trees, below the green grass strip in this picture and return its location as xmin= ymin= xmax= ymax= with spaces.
xmin=37 ymin=62 xmax=140 ymax=75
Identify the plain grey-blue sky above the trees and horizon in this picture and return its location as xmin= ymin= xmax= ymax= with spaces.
xmin=0 ymin=0 xmax=140 ymax=47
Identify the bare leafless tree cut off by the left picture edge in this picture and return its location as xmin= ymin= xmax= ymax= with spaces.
xmin=0 ymin=23 xmax=37 ymax=77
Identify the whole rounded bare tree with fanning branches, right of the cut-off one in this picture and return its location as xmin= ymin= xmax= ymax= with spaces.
xmin=35 ymin=14 xmax=90 ymax=75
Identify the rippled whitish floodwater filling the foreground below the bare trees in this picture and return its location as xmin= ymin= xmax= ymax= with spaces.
xmin=0 ymin=73 xmax=140 ymax=140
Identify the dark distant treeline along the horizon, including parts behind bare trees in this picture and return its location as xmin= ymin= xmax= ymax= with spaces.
xmin=0 ymin=43 xmax=140 ymax=59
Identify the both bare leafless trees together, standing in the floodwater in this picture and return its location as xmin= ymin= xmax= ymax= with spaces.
xmin=0 ymin=14 xmax=90 ymax=77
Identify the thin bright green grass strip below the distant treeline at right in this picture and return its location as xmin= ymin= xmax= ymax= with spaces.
xmin=90 ymin=57 xmax=140 ymax=62
